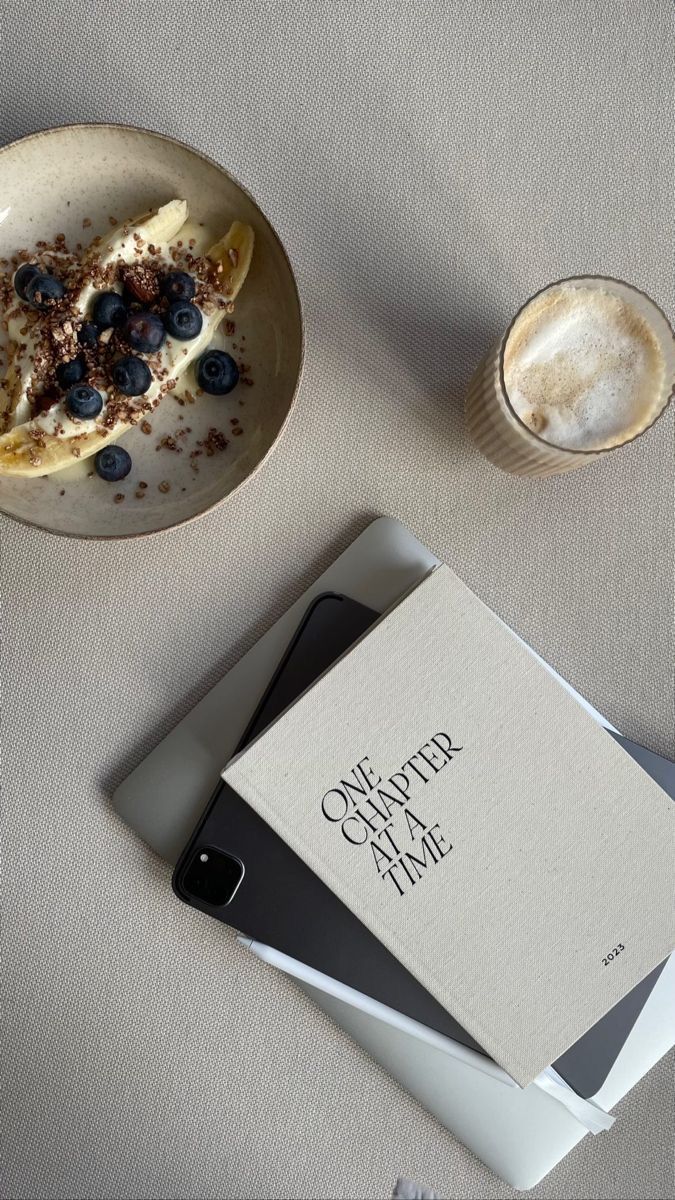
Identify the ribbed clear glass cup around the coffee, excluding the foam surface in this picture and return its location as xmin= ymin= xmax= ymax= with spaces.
xmin=466 ymin=275 xmax=675 ymax=476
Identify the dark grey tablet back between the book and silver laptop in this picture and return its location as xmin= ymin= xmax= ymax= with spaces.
xmin=173 ymin=595 xmax=675 ymax=1097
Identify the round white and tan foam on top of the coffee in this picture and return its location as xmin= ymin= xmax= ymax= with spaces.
xmin=504 ymin=284 xmax=665 ymax=450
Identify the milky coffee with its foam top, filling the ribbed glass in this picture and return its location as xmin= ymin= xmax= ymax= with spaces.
xmin=466 ymin=276 xmax=675 ymax=475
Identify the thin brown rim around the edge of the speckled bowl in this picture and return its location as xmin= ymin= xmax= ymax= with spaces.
xmin=0 ymin=121 xmax=306 ymax=541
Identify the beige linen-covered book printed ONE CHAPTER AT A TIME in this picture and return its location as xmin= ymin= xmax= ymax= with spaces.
xmin=223 ymin=566 xmax=675 ymax=1085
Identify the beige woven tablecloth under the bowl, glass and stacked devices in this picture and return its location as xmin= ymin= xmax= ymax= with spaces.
xmin=0 ymin=0 xmax=675 ymax=1200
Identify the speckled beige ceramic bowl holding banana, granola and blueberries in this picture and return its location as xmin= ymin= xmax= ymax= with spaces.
xmin=0 ymin=125 xmax=303 ymax=538
